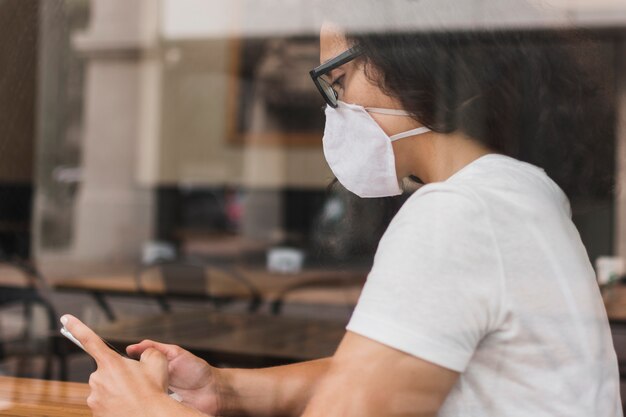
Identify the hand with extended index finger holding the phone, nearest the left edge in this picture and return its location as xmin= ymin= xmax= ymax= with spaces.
xmin=61 ymin=315 xmax=175 ymax=417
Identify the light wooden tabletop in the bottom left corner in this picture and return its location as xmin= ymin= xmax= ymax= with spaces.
xmin=0 ymin=377 xmax=91 ymax=417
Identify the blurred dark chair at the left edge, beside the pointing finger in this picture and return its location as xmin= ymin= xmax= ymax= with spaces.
xmin=0 ymin=260 xmax=58 ymax=379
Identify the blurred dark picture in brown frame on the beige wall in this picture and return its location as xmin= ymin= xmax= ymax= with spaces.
xmin=227 ymin=37 xmax=325 ymax=147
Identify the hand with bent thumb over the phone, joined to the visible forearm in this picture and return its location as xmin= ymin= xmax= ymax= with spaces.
xmin=126 ymin=340 xmax=225 ymax=415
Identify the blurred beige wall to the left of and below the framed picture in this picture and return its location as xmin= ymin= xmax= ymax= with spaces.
xmin=146 ymin=39 xmax=333 ymax=189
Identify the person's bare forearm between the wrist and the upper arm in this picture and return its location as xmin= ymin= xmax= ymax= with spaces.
xmin=220 ymin=358 xmax=330 ymax=417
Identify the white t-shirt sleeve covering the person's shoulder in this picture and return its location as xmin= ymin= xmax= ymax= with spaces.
xmin=347 ymin=186 xmax=502 ymax=372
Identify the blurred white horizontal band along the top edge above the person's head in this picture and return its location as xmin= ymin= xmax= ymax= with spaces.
xmin=161 ymin=0 xmax=626 ymax=39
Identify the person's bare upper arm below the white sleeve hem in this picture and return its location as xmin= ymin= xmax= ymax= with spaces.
xmin=303 ymin=332 xmax=459 ymax=417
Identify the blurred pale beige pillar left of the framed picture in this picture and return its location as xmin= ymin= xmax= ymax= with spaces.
xmin=66 ymin=0 xmax=160 ymax=263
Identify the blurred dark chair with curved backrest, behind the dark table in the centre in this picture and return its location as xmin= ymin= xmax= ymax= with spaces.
xmin=135 ymin=260 xmax=262 ymax=312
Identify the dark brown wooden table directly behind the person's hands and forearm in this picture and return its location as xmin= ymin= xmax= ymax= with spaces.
xmin=95 ymin=310 xmax=346 ymax=367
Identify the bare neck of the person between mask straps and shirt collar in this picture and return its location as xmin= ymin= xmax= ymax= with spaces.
xmin=394 ymin=132 xmax=493 ymax=183
